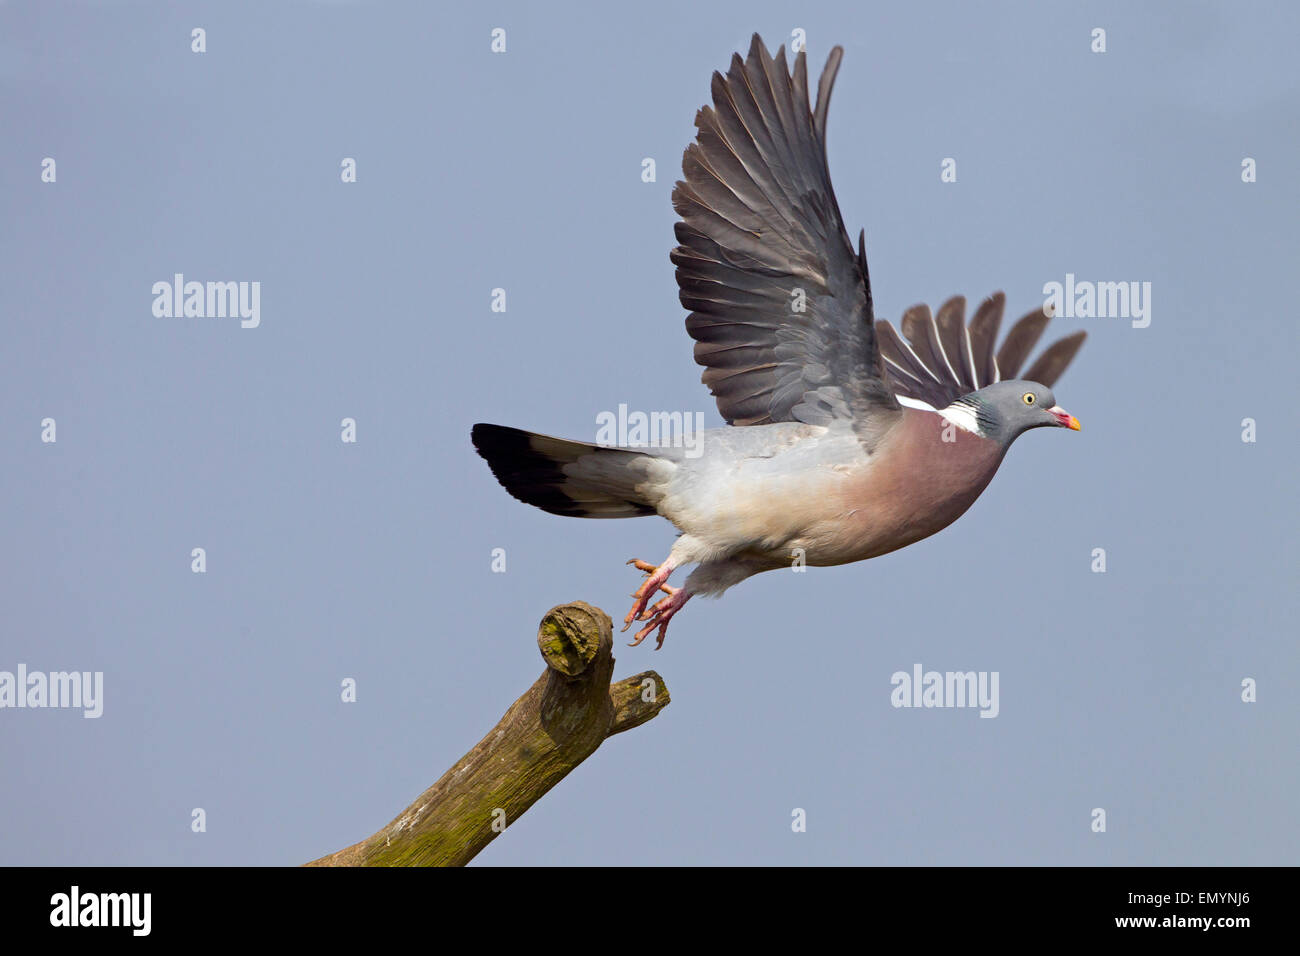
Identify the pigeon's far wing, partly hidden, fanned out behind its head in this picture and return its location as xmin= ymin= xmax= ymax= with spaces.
xmin=876 ymin=293 xmax=1088 ymax=408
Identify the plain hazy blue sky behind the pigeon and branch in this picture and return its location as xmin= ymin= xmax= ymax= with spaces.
xmin=0 ymin=1 xmax=1300 ymax=865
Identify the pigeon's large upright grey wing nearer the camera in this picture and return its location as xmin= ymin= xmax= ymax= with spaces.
xmin=672 ymin=34 xmax=901 ymax=446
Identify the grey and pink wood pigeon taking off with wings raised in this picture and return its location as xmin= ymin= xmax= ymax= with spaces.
xmin=472 ymin=34 xmax=1086 ymax=646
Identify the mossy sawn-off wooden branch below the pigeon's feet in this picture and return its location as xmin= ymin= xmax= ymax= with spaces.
xmin=307 ymin=601 xmax=670 ymax=866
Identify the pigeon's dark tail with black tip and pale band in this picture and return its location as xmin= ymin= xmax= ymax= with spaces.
xmin=469 ymin=424 xmax=676 ymax=518
